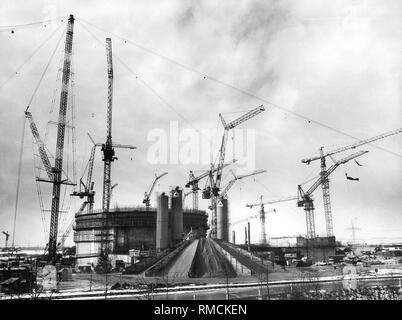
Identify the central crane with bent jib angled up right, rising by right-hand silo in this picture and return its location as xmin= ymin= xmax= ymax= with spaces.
xmin=203 ymin=105 xmax=265 ymax=237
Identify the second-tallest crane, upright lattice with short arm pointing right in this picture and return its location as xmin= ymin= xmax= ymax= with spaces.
xmin=101 ymin=38 xmax=136 ymax=213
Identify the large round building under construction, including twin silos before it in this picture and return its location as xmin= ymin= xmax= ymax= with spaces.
xmin=74 ymin=194 xmax=208 ymax=266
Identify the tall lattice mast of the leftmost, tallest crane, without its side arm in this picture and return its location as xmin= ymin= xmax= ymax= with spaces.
xmin=48 ymin=15 xmax=74 ymax=262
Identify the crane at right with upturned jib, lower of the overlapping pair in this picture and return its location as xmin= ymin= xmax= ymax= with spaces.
xmin=297 ymin=151 xmax=368 ymax=239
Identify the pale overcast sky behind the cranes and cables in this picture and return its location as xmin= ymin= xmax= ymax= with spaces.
xmin=0 ymin=0 xmax=402 ymax=245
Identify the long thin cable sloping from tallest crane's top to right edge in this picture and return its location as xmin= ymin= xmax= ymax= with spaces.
xmin=80 ymin=18 xmax=402 ymax=158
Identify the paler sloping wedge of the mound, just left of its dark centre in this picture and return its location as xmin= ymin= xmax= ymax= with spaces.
xmin=166 ymin=239 xmax=199 ymax=278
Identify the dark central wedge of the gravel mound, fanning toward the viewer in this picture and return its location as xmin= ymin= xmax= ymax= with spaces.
xmin=189 ymin=238 xmax=236 ymax=278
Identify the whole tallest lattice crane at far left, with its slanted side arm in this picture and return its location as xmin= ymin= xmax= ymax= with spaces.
xmin=25 ymin=15 xmax=74 ymax=263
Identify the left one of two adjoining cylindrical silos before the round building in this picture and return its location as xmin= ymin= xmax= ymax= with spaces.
xmin=156 ymin=193 xmax=169 ymax=251
